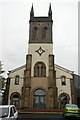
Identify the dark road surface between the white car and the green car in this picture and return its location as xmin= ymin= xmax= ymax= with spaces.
xmin=19 ymin=113 xmax=77 ymax=120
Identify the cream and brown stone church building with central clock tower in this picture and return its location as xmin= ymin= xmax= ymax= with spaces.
xmin=7 ymin=5 xmax=75 ymax=109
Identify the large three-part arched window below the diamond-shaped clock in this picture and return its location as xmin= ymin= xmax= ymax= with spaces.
xmin=34 ymin=62 xmax=46 ymax=77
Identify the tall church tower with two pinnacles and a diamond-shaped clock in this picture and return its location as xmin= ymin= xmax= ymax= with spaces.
xmin=21 ymin=4 xmax=57 ymax=109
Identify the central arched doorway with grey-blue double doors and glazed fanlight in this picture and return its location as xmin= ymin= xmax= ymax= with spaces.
xmin=33 ymin=88 xmax=46 ymax=109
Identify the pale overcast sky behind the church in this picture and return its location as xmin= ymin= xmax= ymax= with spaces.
xmin=0 ymin=0 xmax=78 ymax=77
